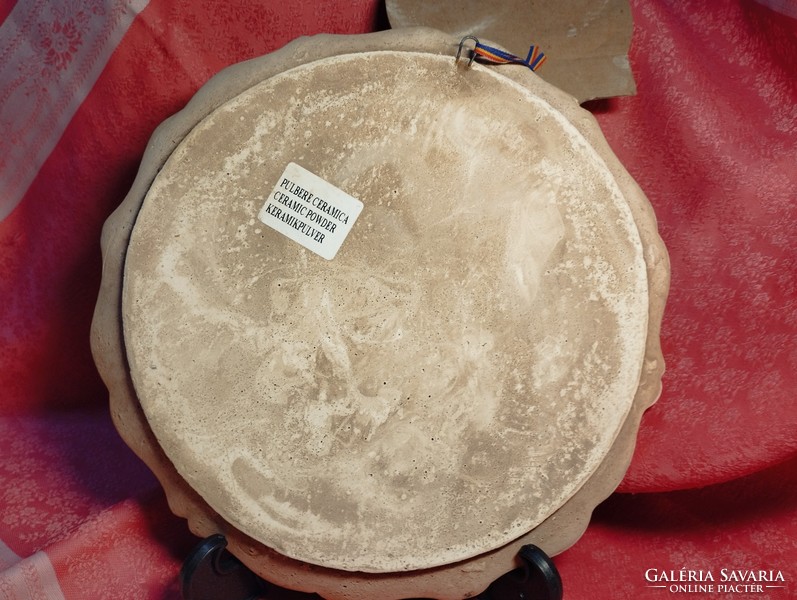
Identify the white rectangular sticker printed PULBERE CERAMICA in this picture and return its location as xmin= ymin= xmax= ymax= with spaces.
xmin=257 ymin=163 xmax=363 ymax=260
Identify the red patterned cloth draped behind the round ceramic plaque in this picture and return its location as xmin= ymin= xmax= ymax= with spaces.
xmin=0 ymin=0 xmax=797 ymax=600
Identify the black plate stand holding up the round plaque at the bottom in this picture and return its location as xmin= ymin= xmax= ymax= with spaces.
xmin=180 ymin=535 xmax=562 ymax=600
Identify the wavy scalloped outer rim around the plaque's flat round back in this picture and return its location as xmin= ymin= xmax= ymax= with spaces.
xmin=94 ymin=31 xmax=667 ymax=598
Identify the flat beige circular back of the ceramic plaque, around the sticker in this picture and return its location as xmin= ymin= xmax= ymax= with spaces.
xmin=123 ymin=52 xmax=648 ymax=572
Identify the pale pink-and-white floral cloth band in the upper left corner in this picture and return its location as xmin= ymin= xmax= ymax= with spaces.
xmin=0 ymin=0 xmax=147 ymax=219
